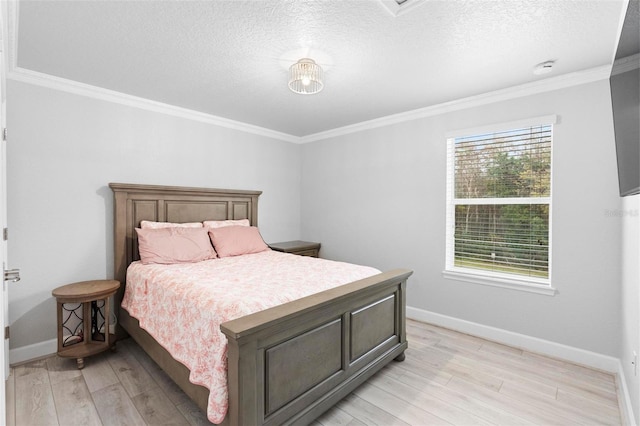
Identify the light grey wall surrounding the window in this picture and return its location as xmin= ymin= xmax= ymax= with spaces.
xmin=302 ymin=80 xmax=621 ymax=357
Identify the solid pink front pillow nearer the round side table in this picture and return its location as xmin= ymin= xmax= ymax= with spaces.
xmin=136 ymin=227 xmax=217 ymax=264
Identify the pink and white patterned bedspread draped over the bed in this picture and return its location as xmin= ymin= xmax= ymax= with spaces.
xmin=122 ymin=250 xmax=380 ymax=423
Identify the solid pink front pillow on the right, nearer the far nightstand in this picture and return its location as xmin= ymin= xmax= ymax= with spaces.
xmin=209 ymin=226 xmax=269 ymax=257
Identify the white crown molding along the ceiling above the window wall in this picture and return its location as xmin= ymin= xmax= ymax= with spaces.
xmin=299 ymin=65 xmax=611 ymax=143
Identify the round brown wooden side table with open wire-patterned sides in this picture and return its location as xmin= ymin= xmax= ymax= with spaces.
xmin=51 ymin=280 xmax=120 ymax=368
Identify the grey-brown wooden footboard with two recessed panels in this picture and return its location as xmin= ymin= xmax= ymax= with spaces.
xmin=221 ymin=270 xmax=412 ymax=425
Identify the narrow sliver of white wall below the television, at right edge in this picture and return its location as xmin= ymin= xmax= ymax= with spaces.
xmin=624 ymin=195 xmax=640 ymax=423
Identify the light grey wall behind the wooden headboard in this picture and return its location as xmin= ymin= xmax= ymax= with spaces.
xmin=7 ymin=81 xmax=300 ymax=348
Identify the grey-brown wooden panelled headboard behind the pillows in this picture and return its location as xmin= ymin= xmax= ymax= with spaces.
xmin=109 ymin=183 xmax=262 ymax=306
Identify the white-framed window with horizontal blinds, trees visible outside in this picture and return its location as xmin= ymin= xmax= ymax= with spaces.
xmin=445 ymin=117 xmax=555 ymax=294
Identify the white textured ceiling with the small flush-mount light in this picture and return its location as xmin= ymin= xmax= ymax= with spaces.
xmin=14 ymin=0 xmax=626 ymax=136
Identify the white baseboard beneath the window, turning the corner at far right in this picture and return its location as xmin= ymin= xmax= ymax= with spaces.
xmin=407 ymin=306 xmax=636 ymax=425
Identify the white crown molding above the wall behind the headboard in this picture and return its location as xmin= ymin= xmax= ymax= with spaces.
xmin=7 ymin=67 xmax=299 ymax=143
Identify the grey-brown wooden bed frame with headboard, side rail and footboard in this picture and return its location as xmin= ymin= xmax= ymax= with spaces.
xmin=109 ymin=183 xmax=412 ymax=425
